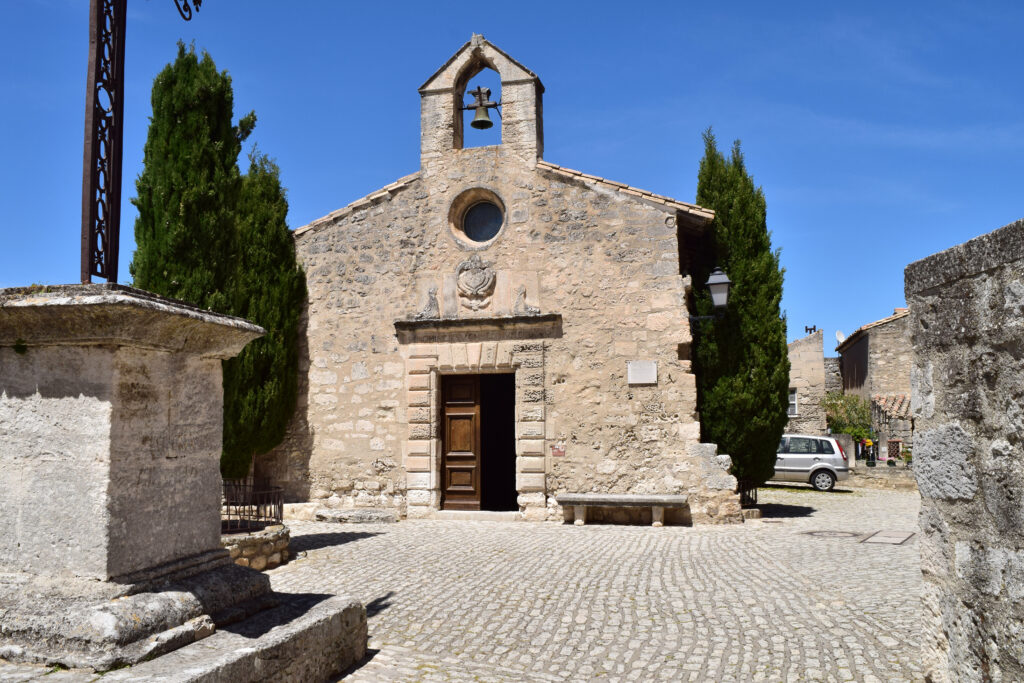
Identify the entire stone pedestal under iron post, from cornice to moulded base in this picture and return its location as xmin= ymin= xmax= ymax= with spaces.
xmin=0 ymin=285 xmax=269 ymax=669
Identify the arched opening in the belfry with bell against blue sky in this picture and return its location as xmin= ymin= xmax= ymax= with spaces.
xmin=453 ymin=60 xmax=502 ymax=150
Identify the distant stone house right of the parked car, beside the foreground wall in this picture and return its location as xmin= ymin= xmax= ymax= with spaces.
xmin=836 ymin=308 xmax=913 ymax=459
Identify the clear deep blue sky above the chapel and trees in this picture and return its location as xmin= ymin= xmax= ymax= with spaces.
xmin=0 ymin=0 xmax=1024 ymax=353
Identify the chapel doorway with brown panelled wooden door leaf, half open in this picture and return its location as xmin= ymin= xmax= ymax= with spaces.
xmin=441 ymin=374 xmax=518 ymax=510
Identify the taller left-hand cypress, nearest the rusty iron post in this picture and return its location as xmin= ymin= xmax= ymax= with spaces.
xmin=130 ymin=43 xmax=256 ymax=312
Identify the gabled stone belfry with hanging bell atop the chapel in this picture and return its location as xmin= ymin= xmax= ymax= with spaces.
xmin=420 ymin=34 xmax=544 ymax=173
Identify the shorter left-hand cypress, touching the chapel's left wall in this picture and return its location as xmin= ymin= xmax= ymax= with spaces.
xmin=220 ymin=152 xmax=306 ymax=478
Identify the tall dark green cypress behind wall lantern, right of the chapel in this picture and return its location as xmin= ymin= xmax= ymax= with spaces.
xmin=693 ymin=128 xmax=790 ymax=485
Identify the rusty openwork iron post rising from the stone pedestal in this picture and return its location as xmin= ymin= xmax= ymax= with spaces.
xmin=82 ymin=0 xmax=203 ymax=283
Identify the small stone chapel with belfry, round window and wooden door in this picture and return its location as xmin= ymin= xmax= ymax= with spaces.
xmin=257 ymin=35 xmax=741 ymax=523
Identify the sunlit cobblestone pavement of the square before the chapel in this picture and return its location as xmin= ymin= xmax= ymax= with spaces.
xmin=268 ymin=487 xmax=921 ymax=682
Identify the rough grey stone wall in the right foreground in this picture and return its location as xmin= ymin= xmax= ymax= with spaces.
xmin=906 ymin=221 xmax=1024 ymax=681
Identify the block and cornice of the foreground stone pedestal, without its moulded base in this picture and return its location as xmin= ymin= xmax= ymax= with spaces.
xmin=0 ymin=285 xmax=262 ymax=580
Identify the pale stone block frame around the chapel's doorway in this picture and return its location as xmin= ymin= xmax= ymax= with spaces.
xmin=401 ymin=340 xmax=548 ymax=519
